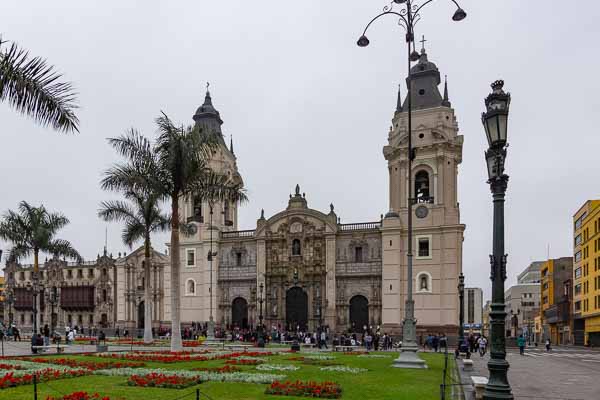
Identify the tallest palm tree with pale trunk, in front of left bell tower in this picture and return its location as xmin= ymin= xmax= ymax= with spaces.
xmin=111 ymin=113 xmax=247 ymax=351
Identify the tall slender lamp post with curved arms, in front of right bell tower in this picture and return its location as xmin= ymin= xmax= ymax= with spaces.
xmin=356 ymin=0 xmax=467 ymax=368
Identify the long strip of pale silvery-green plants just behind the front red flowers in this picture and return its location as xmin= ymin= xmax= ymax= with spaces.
xmin=94 ymin=368 xmax=285 ymax=384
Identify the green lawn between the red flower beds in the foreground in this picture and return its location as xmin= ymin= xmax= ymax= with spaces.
xmin=0 ymin=353 xmax=452 ymax=400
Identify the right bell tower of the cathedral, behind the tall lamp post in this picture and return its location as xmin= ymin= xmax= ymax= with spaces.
xmin=382 ymin=48 xmax=465 ymax=336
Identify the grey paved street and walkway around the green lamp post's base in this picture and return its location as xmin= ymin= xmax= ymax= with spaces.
xmin=459 ymin=348 xmax=600 ymax=400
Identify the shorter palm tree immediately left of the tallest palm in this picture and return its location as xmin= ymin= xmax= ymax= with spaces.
xmin=98 ymin=144 xmax=169 ymax=343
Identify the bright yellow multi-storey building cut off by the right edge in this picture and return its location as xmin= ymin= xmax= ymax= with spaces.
xmin=573 ymin=200 xmax=600 ymax=346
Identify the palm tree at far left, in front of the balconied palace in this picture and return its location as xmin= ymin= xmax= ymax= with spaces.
xmin=0 ymin=201 xmax=83 ymax=332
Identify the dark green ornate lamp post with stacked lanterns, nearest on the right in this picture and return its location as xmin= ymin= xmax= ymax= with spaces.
xmin=481 ymin=80 xmax=513 ymax=399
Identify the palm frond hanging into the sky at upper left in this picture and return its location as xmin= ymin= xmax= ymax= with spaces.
xmin=0 ymin=37 xmax=79 ymax=132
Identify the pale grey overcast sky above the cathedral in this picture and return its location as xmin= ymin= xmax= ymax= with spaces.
xmin=0 ymin=0 xmax=600 ymax=298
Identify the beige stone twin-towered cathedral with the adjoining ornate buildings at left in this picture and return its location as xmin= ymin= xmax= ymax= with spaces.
xmin=5 ymin=49 xmax=465 ymax=336
